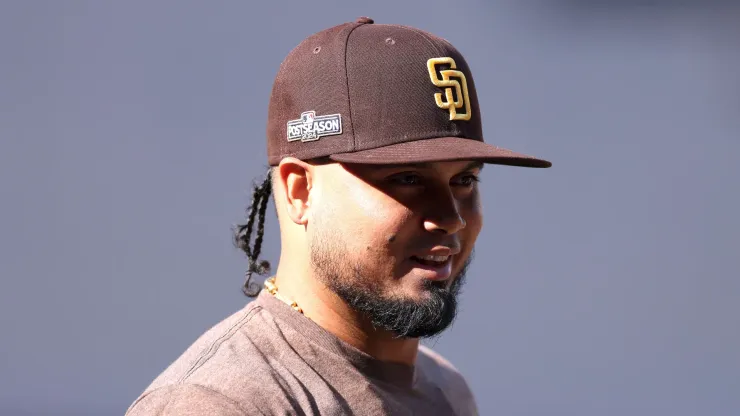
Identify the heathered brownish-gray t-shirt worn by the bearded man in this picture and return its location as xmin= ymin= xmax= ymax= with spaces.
xmin=126 ymin=290 xmax=477 ymax=416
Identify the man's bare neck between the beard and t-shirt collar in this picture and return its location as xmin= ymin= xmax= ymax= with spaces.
xmin=275 ymin=268 xmax=419 ymax=365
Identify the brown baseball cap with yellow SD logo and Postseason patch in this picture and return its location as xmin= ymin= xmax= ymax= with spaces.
xmin=267 ymin=17 xmax=551 ymax=168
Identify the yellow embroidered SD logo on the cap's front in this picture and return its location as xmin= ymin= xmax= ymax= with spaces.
xmin=427 ymin=57 xmax=471 ymax=120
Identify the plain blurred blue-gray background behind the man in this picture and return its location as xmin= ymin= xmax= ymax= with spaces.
xmin=0 ymin=0 xmax=740 ymax=415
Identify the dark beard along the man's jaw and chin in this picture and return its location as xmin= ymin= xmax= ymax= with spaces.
xmin=311 ymin=229 xmax=473 ymax=338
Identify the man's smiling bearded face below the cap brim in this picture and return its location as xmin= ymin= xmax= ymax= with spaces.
xmin=308 ymin=161 xmax=483 ymax=338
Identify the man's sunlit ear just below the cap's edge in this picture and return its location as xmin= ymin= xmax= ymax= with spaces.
xmin=275 ymin=157 xmax=313 ymax=226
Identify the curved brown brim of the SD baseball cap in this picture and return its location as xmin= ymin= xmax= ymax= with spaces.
xmin=330 ymin=137 xmax=552 ymax=168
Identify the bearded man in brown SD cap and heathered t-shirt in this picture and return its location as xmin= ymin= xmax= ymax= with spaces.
xmin=128 ymin=18 xmax=550 ymax=416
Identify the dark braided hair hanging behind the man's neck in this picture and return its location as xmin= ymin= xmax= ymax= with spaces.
xmin=234 ymin=169 xmax=272 ymax=297
